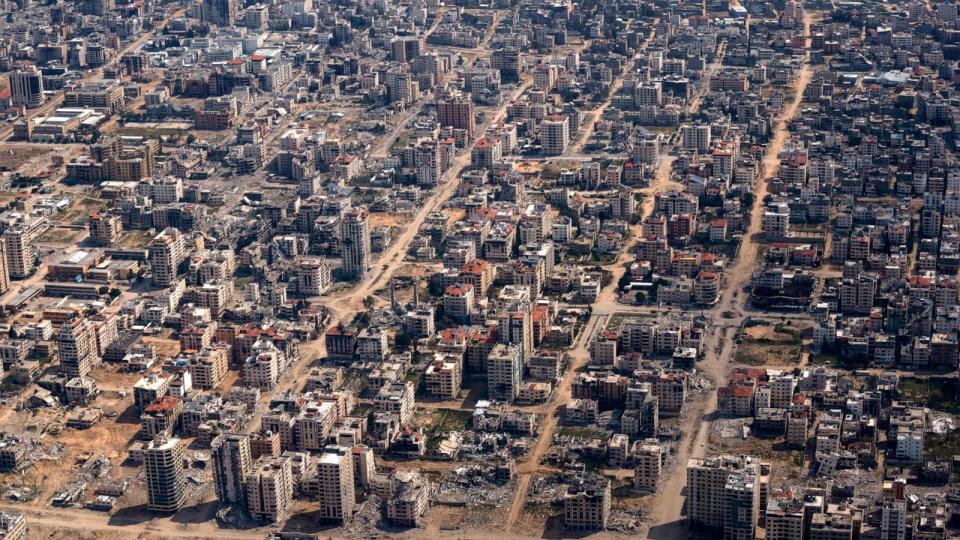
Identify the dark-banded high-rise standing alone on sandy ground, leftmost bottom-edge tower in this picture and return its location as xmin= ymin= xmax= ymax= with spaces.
xmin=143 ymin=437 xmax=186 ymax=512
